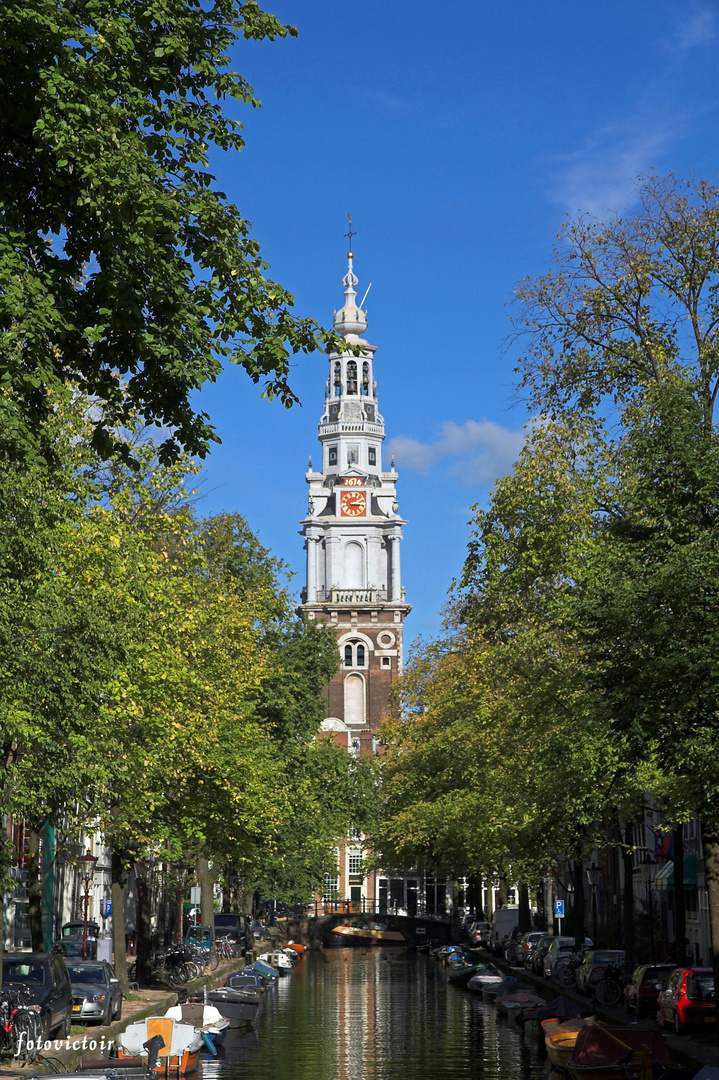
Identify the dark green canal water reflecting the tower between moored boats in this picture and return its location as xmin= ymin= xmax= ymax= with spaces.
xmin=201 ymin=948 xmax=550 ymax=1080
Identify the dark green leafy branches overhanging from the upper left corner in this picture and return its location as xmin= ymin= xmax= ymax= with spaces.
xmin=0 ymin=0 xmax=332 ymax=460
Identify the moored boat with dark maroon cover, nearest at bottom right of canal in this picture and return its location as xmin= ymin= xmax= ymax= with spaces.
xmin=565 ymin=1024 xmax=669 ymax=1080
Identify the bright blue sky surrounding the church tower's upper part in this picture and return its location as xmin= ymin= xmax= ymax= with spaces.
xmin=196 ymin=0 xmax=719 ymax=640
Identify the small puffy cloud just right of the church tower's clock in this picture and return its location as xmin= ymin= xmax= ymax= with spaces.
xmin=386 ymin=420 xmax=526 ymax=486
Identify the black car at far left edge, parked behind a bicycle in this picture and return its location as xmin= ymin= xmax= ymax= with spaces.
xmin=2 ymin=953 xmax=72 ymax=1040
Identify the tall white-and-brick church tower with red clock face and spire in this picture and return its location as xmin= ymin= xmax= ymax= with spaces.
xmin=300 ymin=248 xmax=410 ymax=754
